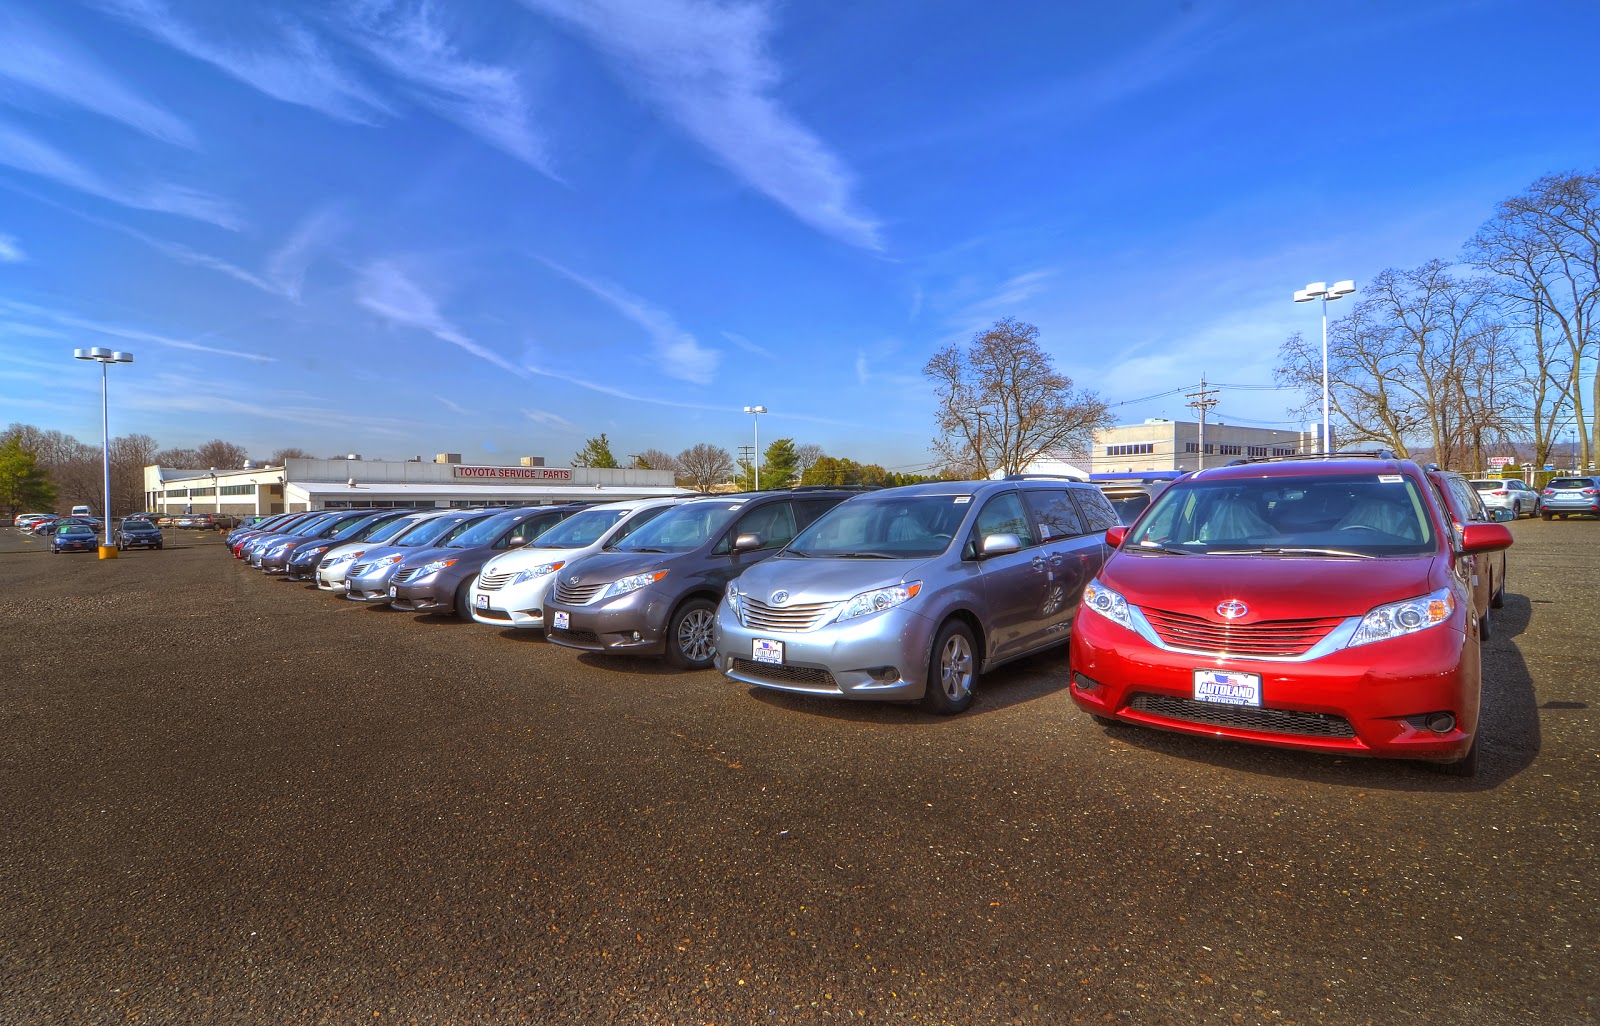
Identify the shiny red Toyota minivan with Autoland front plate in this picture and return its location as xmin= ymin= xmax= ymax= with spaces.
xmin=1069 ymin=453 xmax=1512 ymax=776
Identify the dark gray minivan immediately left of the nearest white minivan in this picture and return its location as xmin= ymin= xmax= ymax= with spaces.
xmin=389 ymin=503 xmax=584 ymax=619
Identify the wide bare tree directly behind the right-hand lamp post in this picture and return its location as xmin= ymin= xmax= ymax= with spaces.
xmin=1277 ymin=259 xmax=1520 ymax=466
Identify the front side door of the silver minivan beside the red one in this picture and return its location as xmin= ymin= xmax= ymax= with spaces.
xmin=963 ymin=490 xmax=1051 ymax=664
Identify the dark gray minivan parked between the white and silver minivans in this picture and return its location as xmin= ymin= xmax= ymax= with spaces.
xmin=544 ymin=488 xmax=859 ymax=669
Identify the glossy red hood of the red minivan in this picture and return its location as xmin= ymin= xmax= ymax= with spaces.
xmin=1099 ymin=551 xmax=1450 ymax=624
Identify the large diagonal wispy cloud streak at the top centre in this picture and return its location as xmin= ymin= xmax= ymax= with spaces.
xmin=523 ymin=0 xmax=883 ymax=251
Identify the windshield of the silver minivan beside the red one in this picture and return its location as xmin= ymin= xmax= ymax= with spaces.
xmin=784 ymin=495 xmax=973 ymax=559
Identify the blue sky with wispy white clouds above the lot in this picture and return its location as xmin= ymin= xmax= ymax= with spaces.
xmin=0 ymin=0 xmax=1600 ymax=471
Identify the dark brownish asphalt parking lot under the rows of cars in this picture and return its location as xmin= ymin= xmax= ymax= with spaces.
xmin=0 ymin=520 xmax=1600 ymax=1026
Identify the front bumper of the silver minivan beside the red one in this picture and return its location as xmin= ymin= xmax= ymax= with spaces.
xmin=715 ymin=599 xmax=936 ymax=701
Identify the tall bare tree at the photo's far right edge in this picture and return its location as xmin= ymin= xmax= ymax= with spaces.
xmin=1466 ymin=171 xmax=1600 ymax=466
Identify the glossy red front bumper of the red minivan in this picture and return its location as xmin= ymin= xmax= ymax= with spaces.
xmin=1069 ymin=611 xmax=1482 ymax=762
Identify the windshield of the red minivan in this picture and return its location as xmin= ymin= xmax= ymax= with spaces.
xmin=1123 ymin=474 xmax=1435 ymax=555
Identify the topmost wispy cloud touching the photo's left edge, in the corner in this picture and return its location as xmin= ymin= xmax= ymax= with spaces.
xmin=0 ymin=6 xmax=195 ymax=147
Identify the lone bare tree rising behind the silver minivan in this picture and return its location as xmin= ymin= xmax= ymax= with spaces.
xmin=923 ymin=317 xmax=1110 ymax=477
